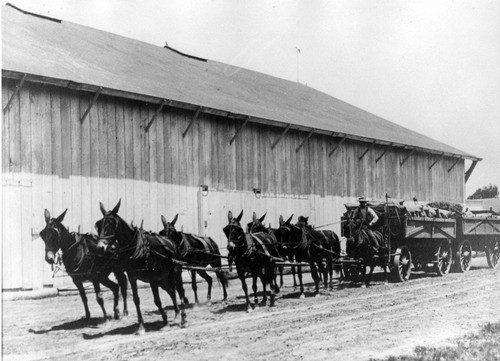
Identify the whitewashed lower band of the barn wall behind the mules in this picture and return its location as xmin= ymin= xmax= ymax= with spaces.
xmin=2 ymin=173 xmax=354 ymax=290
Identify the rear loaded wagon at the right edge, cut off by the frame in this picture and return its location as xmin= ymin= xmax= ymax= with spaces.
xmin=453 ymin=214 xmax=500 ymax=272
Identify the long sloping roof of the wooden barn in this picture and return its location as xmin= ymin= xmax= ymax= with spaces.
xmin=2 ymin=6 xmax=479 ymax=160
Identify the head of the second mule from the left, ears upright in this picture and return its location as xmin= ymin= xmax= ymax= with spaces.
xmin=95 ymin=199 xmax=123 ymax=252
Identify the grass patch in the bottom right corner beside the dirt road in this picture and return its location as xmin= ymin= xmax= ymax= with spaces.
xmin=370 ymin=322 xmax=500 ymax=361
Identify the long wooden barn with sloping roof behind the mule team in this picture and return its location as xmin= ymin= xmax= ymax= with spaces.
xmin=2 ymin=5 xmax=480 ymax=290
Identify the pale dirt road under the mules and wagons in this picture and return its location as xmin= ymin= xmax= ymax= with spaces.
xmin=2 ymin=258 xmax=500 ymax=361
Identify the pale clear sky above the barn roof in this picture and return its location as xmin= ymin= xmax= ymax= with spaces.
xmin=2 ymin=0 xmax=500 ymax=195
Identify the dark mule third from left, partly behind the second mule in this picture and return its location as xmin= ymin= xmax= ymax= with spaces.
xmin=160 ymin=214 xmax=227 ymax=304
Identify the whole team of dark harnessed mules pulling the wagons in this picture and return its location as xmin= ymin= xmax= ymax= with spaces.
xmin=40 ymin=201 xmax=385 ymax=334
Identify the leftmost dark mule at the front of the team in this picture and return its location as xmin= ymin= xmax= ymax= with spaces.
xmin=40 ymin=209 xmax=128 ymax=321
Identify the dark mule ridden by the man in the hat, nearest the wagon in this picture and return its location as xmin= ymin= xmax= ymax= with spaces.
xmin=347 ymin=227 xmax=389 ymax=287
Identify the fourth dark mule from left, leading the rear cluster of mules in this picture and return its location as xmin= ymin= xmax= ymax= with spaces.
xmin=223 ymin=211 xmax=279 ymax=312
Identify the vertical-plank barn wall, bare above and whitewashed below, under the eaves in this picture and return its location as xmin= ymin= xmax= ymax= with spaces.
xmin=2 ymin=79 xmax=464 ymax=288
